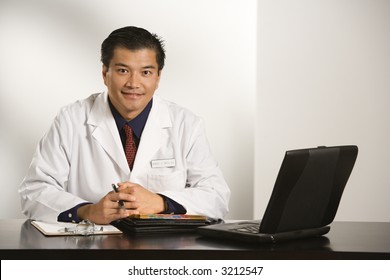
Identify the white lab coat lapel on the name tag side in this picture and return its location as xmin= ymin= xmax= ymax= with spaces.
xmin=131 ymin=96 xmax=172 ymax=178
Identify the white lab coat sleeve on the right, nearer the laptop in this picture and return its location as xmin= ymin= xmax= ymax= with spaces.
xmin=158 ymin=119 xmax=230 ymax=219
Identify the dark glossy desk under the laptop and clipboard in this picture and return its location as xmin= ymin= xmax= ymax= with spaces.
xmin=0 ymin=220 xmax=390 ymax=260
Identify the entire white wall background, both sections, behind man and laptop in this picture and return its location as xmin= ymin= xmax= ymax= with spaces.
xmin=0 ymin=0 xmax=390 ymax=221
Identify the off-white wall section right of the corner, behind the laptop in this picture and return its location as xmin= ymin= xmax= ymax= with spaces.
xmin=254 ymin=0 xmax=390 ymax=222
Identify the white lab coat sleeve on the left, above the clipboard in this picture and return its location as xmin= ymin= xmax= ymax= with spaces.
xmin=19 ymin=109 xmax=85 ymax=222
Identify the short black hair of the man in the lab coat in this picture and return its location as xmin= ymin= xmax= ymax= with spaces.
xmin=101 ymin=26 xmax=165 ymax=73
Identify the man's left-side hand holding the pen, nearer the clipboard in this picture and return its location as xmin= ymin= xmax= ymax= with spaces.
xmin=77 ymin=188 xmax=138 ymax=225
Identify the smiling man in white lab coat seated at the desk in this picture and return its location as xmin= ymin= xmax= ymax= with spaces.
xmin=19 ymin=27 xmax=230 ymax=224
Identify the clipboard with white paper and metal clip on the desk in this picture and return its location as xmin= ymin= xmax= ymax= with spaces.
xmin=31 ymin=221 xmax=122 ymax=236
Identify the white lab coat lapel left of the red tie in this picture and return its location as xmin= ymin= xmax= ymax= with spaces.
xmin=87 ymin=93 xmax=130 ymax=173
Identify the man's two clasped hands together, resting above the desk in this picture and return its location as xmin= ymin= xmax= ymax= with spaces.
xmin=77 ymin=182 xmax=164 ymax=224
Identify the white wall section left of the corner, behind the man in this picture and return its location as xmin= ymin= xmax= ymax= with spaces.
xmin=0 ymin=0 xmax=257 ymax=219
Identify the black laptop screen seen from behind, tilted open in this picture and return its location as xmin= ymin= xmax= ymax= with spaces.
xmin=260 ymin=146 xmax=358 ymax=233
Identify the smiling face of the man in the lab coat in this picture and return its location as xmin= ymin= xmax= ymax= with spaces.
xmin=103 ymin=48 xmax=160 ymax=121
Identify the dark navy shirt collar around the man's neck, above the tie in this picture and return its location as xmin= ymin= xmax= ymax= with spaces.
xmin=108 ymin=98 xmax=153 ymax=139
